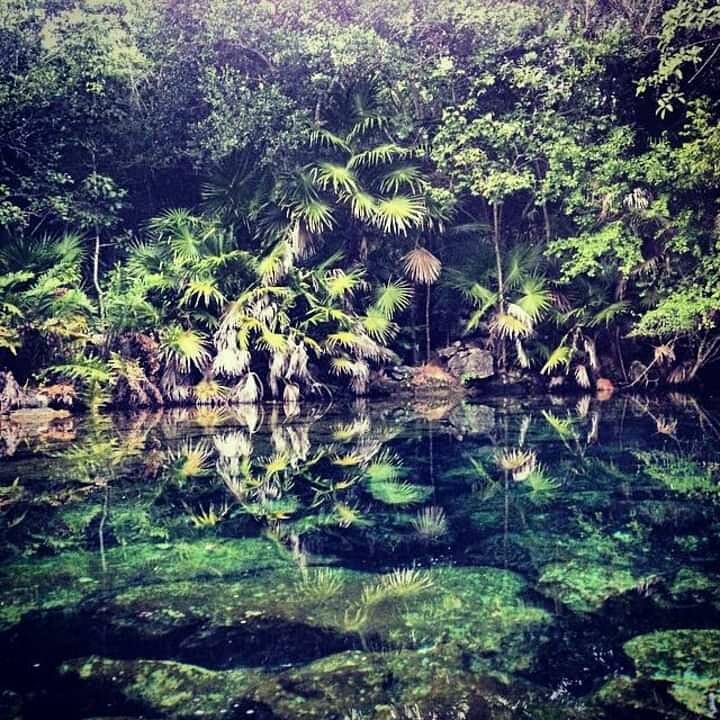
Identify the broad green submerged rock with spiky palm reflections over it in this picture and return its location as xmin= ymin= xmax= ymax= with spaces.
xmin=101 ymin=568 xmax=550 ymax=673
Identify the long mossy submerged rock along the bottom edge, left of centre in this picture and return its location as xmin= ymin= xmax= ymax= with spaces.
xmin=62 ymin=648 xmax=515 ymax=720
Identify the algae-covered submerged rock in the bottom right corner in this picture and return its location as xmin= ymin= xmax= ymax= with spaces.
xmin=624 ymin=630 xmax=720 ymax=718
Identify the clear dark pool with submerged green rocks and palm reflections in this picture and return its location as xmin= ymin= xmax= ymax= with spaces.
xmin=0 ymin=395 xmax=720 ymax=720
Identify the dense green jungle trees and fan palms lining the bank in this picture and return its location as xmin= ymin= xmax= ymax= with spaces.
xmin=0 ymin=0 xmax=720 ymax=405
